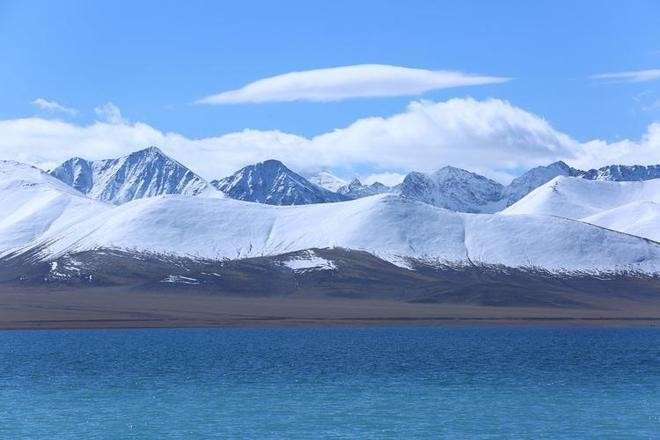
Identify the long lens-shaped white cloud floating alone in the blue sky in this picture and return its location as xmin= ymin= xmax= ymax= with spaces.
xmin=197 ymin=64 xmax=509 ymax=104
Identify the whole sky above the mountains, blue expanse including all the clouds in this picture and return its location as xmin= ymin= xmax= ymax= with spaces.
xmin=0 ymin=0 xmax=660 ymax=183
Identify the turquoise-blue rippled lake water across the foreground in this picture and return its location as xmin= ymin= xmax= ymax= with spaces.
xmin=0 ymin=327 xmax=660 ymax=439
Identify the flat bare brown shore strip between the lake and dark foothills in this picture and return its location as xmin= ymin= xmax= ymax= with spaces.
xmin=0 ymin=290 xmax=660 ymax=330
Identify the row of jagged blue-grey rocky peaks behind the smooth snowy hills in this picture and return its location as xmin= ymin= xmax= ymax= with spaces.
xmin=50 ymin=147 xmax=660 ymax=213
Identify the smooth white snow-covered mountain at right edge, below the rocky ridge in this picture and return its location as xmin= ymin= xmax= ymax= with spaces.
xmin=502 ymin=177 xmax=660 ymax=241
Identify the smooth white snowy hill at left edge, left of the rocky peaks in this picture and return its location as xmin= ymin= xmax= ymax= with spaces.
xmin=0 ymin=161 xmax=111 ymax=255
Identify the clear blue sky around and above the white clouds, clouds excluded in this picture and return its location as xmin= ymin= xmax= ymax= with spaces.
xmin=0 ymin=0 xmax=660 ymax=180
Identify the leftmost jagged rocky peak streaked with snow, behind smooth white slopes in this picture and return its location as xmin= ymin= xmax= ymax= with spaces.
xmin=50 ymin=147 xmax=216 ymax=204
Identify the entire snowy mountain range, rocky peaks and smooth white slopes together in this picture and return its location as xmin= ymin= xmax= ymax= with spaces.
xmin=0 ymin=147 xmax=660 ymax=298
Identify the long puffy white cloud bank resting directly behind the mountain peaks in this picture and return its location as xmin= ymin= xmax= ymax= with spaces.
xmin=0 ymin=98 xmax=660 ymax=182
